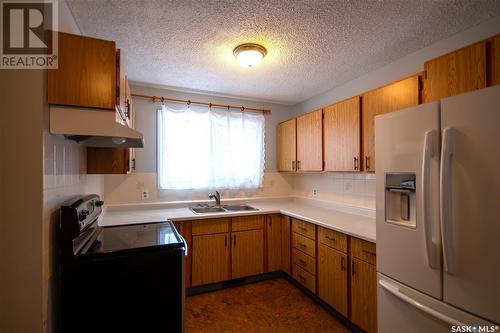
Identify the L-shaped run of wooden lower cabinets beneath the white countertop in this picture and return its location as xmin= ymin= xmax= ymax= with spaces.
xmin=175 ymin=214 xmax=377 ymax=332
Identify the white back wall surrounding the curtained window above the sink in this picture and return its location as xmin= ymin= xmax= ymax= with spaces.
xmin=104 ymin=84 xmax=293 ymax=204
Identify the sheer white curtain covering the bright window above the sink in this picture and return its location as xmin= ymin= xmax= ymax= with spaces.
xmin=158 ymin=103 xmax=265 ymax=190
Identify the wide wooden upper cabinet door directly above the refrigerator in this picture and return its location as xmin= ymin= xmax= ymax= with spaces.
xmin=423 ymin=42 xmax=486 ymax=103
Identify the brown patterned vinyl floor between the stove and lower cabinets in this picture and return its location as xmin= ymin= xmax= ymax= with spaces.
xmin=185 ymin=278 xmax=350 ymax=333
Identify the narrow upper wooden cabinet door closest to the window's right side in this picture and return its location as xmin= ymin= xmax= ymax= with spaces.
xmin=277 ymin=119 xmax=297 ymax=171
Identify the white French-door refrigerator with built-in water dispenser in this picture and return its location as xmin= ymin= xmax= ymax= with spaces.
xmin=375 ymin=86 xmax=500 ymax=333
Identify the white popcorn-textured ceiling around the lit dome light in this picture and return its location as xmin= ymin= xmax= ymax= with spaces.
xmin=68 ymin=0 xmax=500 ymax=104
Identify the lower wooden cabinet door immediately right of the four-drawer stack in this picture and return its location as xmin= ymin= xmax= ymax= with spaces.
xmin=318 ymin=244 xmax=347 ymax=317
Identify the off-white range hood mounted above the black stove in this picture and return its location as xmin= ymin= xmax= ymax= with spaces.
xmin=50 ymin=105 xmax=144 ymax=148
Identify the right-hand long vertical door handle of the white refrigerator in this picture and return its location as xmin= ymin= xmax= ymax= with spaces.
xmin=439 ymin=127 xmax=454 ymax=275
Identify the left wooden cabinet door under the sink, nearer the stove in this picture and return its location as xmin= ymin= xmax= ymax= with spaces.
xmin=191 ymin=234 xmax=230 ymax=286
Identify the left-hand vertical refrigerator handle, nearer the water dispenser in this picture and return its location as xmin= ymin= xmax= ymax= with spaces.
xmin=422 ymin=130 xmax=438 ymax=269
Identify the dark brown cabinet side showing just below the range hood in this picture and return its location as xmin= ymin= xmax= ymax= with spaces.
xmin=87 ymin=147 xmax=131 ymax=174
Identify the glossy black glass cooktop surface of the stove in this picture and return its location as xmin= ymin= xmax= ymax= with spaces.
xmin=87 ymin=222 xmax=184 ymax=254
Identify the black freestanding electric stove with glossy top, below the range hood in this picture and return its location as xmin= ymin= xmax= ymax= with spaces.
xmin=59 ymin=195 xmax=187 ymax=332
